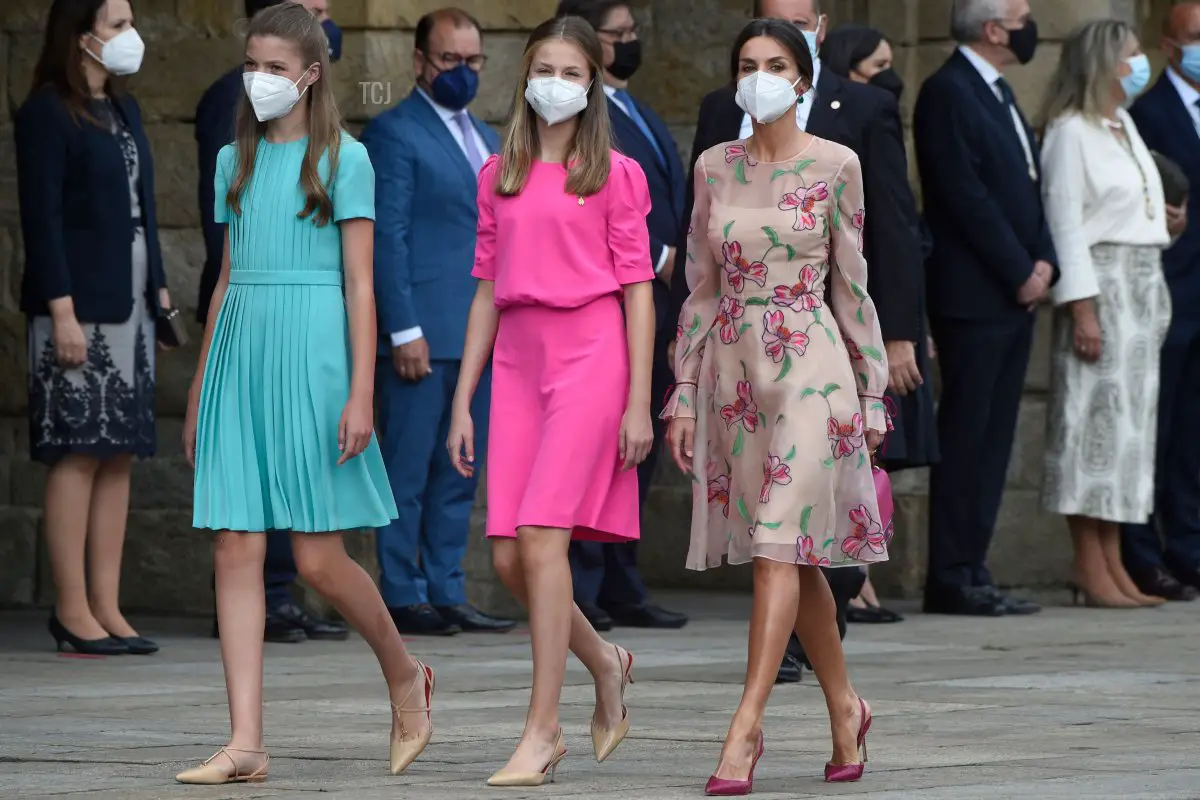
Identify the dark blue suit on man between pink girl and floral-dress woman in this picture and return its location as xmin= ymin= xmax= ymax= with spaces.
xmin=570 ymin=95 xmax=688 ymax=606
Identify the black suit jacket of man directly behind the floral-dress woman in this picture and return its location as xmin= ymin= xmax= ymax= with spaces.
xmin=671 ymin=70 xmax=924 ymax=342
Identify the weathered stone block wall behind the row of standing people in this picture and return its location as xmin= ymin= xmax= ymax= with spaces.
xmin=0 ymin=0 xmax=1169 ymax=612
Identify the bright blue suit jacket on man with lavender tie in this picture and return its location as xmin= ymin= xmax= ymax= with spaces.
xmin=360 ymin=89 xmax=500 ymax=361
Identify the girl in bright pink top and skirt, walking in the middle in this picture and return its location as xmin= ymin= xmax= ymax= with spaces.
xmin=446 ymin=17 xmax=654 ymax=786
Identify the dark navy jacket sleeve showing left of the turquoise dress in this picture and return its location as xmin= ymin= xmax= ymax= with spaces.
xmin=196 ymin=67 xmax=245 ymax=323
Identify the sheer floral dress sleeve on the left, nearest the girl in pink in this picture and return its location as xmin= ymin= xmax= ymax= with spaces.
xmin=660 ymin=155 xmax=721 ymax=420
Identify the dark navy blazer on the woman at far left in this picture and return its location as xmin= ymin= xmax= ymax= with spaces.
xmin=16 ymin=86 xmax=167 ymax=324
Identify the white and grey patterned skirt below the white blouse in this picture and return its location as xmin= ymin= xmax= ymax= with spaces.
xmin=1042 ymin=245 xmax=1171 ymax=523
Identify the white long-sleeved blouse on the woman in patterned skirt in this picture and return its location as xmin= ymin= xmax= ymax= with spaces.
xmin=1042 ymin=109 xmax=1170 ymax=306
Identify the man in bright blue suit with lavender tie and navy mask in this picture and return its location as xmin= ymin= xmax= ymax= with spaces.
xmin=362 ymin=3 xmax=515 ymax=636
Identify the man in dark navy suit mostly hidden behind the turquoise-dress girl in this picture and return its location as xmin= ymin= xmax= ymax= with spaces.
xmin=196 ymin=0 xmax=349 ymax=643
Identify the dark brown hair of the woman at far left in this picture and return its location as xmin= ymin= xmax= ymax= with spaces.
xmin=30 ymin=0 xmax=132 ymax=127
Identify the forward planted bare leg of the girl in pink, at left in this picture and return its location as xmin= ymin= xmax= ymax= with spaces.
xmin=502 ymin=525 xmax=572 ymax=774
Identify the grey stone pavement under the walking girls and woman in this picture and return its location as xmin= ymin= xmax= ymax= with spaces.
xmin=0 ymin=594 xmax=1200 ymax=800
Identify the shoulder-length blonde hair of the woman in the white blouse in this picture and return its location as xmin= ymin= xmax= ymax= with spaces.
xmin=1039 ymin=19 xmax=1135 ymax=130
